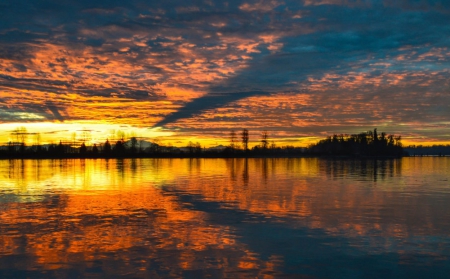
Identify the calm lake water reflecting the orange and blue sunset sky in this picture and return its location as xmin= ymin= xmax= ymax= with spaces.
xmin=0 ymin=158 xmax=450 ymax=278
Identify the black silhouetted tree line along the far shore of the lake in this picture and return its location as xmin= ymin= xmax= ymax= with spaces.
xmin=0 ymin=128 xmax=404 ymax=158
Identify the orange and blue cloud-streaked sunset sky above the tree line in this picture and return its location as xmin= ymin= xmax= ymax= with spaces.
xmin=0 ymin=0 xmax=450 ymax=147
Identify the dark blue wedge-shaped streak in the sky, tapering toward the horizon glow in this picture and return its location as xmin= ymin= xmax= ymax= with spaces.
xmin=149 ymin=1 xmax=450 ymax=125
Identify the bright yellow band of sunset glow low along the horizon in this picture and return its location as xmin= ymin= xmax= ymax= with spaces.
xmin=0 ymin=121 xmax=450 ymax=148
